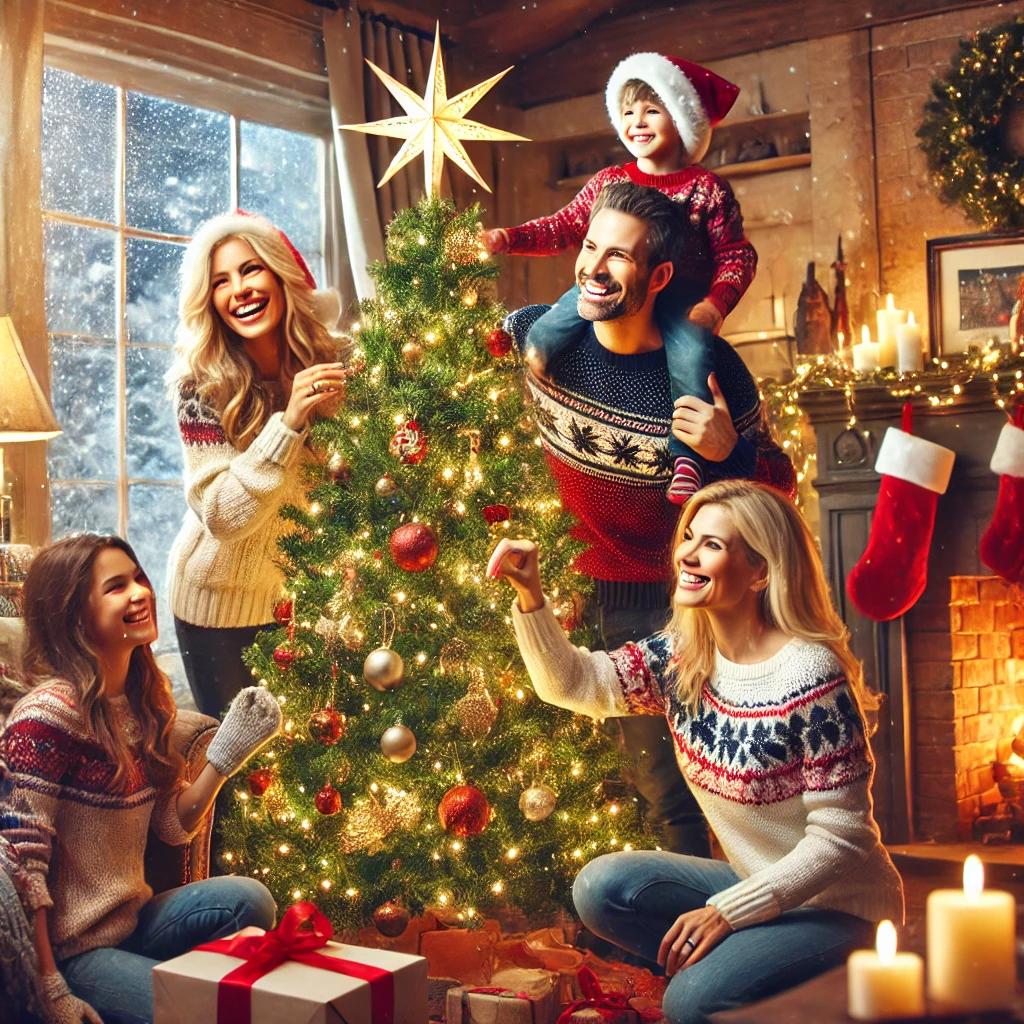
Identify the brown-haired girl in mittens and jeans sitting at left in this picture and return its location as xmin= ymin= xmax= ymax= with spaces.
xmin=0 ymin=534 xmax=281 ymax=1024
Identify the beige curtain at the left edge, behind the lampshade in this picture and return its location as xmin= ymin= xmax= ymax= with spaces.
xmin=0 ymin=0 xmax=49 ymax=545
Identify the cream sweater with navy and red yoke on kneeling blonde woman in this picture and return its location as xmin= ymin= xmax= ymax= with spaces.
xmin=512 ymin=603 xmax=903 ymax=929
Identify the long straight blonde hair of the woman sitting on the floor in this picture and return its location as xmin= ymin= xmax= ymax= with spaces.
xmin=668 ymin=480 xmax=879 ymax=722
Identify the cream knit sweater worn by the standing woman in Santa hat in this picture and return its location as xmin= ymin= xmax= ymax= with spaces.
xmin=167 ymin=388 xmax=305 ymax=628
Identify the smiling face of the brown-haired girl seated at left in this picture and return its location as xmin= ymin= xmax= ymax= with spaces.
xmin=85 ymin=547 xmax=157 ymax=652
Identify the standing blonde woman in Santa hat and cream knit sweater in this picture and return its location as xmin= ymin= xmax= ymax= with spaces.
xmin=168 ymin=211 xmax=345 ymax=715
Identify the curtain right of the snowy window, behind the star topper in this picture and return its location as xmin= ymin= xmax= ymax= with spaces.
xmin=324 ymin=3 xmax=451 ymax=299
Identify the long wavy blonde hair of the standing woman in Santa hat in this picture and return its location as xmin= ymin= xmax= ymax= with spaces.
xmin=168 ymin=226 xmax=342 ymax=450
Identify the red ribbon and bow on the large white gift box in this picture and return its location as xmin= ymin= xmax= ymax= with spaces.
xmin=196 ymin=903 xmax=394 ymax=1024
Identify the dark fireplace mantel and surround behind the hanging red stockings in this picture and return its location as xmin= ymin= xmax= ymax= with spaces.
xmin=800 ymin=374 xmax=1007 ymax=843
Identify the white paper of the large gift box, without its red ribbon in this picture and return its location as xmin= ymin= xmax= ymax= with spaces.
xmin=153 ymin=942 xmax=428 ymax=1024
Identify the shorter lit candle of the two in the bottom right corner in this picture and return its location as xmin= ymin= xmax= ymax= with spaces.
xmin=846 ymin=921 xmax=925 ymax=1021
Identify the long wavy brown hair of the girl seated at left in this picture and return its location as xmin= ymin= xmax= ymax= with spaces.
xmin=24 ymin=534 xmax=184 ymax=793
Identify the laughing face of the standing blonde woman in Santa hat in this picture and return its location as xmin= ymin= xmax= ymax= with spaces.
xmin=210 ymin=239 xmax=285 ymax=341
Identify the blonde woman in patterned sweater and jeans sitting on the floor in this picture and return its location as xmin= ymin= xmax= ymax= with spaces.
xmin=488 ymin=480 xmax=903 ymax=1024
